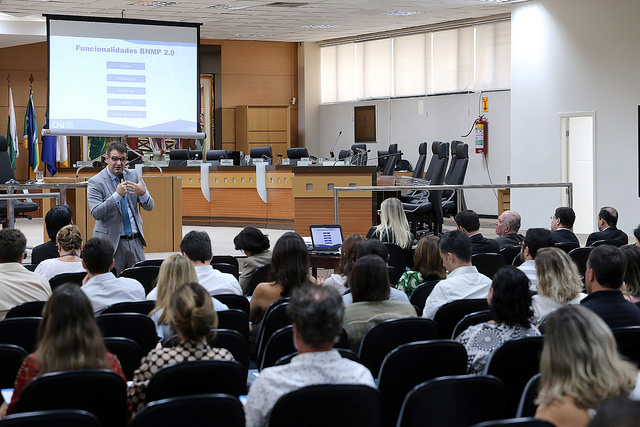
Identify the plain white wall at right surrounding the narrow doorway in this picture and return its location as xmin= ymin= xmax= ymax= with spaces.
xmin=511 ymin=0 xmax=640 ymax=234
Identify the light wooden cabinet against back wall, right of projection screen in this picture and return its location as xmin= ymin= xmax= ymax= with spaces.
xmin=236 ymin=105 xmax=291 ymax=158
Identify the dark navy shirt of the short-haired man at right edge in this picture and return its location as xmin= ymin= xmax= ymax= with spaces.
xmin=580 ymin=289 xmax=640 ymax=329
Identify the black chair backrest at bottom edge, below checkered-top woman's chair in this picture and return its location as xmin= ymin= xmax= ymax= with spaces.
xmin=131 ymin=393 xmax=245 ymax=427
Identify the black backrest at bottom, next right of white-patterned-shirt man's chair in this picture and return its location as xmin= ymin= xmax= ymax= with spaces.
xmin=397 ymin=375 xmax=506 ymax=427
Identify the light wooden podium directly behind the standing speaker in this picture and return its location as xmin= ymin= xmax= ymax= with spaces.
xmin=43 ymin=176 xmax=182 ymax=252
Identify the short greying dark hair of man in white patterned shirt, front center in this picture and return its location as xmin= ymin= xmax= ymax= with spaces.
xmin=287 ymin=285 xmax=344 ymax=348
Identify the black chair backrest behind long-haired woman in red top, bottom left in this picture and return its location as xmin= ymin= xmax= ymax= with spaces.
xmin=17 ymin=369 xmax=127 ymax=427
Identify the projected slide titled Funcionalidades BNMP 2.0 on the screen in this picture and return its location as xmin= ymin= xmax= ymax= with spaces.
xmin=48 ymin=19 xmax=199 ymax=137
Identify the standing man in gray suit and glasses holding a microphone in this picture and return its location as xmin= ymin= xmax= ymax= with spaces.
xmin=87 ymin=141 xmax=154 ymax=274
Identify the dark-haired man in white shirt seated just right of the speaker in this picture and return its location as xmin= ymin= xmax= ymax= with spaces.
xmin=180 ymin=230 xmax=242 ymax=295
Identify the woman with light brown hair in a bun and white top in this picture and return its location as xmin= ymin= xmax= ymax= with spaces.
xmin=34 ymin=225 xmax=84 ymax=280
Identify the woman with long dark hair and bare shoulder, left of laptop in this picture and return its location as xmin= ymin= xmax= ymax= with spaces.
xmin=249 ymin=232 xmax=313 ymax=323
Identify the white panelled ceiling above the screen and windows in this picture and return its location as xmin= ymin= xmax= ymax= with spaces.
xmin=0 ymin=0 xmax=518 ymax=47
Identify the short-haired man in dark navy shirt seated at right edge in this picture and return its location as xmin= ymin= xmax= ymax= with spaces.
xmin=581 ymin=245 xmax=640 ymax=328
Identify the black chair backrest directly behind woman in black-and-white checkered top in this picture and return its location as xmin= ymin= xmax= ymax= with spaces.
xmin=145 ymin=360 xmax=247 ymax=403
